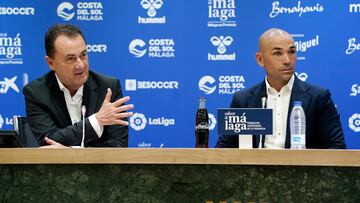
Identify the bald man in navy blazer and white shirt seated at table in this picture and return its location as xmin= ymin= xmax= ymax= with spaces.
xmin=216 ymin=28 xmax=346 ymax=149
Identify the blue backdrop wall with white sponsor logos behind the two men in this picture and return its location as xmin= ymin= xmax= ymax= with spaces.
xmin=0 ymin=0 xmax=360 ymax=149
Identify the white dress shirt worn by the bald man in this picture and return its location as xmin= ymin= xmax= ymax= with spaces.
xmin=264 ymin=75 xmax=295 ymax=149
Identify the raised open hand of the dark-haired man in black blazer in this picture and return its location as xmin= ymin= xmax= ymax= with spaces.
xmin=95 ymin=88 xmax=134 ymax=126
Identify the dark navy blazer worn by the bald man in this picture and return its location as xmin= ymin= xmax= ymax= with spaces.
xmin=216 ymin=77 xmax=346 ymax=149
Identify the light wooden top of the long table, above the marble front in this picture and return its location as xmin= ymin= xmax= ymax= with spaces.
xmin=0 ymin=148 xmax=360 ymax=167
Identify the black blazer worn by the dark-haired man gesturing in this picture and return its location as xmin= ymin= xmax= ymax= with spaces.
xmin=23 ymin=71 xmax=128 ymax=147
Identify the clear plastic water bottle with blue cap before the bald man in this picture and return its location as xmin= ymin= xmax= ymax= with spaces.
xmin=290 ymin=101 xmax=306 ymax=149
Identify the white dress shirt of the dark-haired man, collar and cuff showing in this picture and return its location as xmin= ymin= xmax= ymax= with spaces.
xmin=55 ymin=74 xmax=104 ymax=137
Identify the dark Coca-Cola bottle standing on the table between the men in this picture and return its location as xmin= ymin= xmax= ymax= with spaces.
xmin=195 ymin=97 xmax=209 ymax=148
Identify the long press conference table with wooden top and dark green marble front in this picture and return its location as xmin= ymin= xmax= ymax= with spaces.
xmin=0 ymin=148 xmax=360 ymax=202
